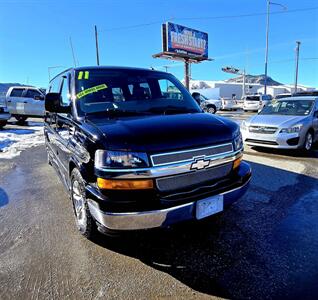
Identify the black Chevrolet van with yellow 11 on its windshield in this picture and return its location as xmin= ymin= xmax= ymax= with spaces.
xmin=44 ymin=67 xmax=251 ymax=238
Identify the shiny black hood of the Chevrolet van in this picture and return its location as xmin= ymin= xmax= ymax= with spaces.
xmin=87 ymin=113 xmax=239 ymax=153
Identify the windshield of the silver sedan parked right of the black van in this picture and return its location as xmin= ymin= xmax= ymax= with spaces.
xmin=259 ymin=100 xmax=314 ymax=116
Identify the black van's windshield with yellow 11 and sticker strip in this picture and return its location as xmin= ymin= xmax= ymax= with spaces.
xmin=75 ymin=69 xmax=201 ymax=116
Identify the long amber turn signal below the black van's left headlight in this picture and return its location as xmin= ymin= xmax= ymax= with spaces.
xmin=97 ymin=178 xmax=153 ymax=190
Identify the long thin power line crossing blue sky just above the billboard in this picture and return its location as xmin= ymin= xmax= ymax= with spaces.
xmin=100 ymin=6 xmax=318 ymax=32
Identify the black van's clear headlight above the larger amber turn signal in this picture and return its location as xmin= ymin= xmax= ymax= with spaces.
xmin=95 ymin=150 xmax=149 ymax=169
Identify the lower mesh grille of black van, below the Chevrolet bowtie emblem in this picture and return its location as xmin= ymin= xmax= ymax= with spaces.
xmin=156 ymin=162 xmax=233 ymax=192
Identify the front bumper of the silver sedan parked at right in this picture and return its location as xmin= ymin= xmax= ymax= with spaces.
xmin=241 ymin=130 xmax=304 ymax=149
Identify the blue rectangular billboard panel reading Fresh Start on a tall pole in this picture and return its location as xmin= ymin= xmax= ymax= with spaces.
xmin=162 ymin=22 xmax=208 ymax=58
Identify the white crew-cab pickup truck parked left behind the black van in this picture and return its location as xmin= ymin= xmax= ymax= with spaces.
xmin=6 ymin=86 xmax=45 ymax=122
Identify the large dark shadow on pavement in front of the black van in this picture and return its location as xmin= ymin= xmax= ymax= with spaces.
xmin=95 ymin=163 xmax=318 ymax=299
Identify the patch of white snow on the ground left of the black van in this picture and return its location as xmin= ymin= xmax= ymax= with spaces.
xmin=0 ymin=122 xmax=44 ymax=159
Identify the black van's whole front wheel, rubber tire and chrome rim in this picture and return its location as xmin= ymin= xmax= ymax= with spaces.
xmin=71 ymin=168 xmax=97 ymax=239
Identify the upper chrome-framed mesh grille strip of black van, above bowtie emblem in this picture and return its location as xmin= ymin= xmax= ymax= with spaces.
xmin=151 ymin=143 xmax=233 ymax=166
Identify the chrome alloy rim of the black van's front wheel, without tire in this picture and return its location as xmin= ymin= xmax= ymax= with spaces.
xmin=72 ymin=180 xmax=87 ymax=230
